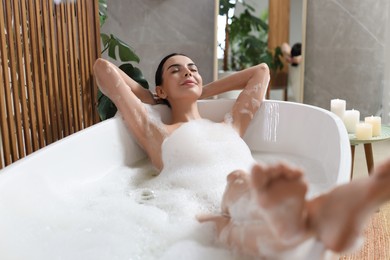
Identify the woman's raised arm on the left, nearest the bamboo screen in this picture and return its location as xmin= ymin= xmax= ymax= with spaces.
xmin=93 ymin=59 xmax=166 ymax=169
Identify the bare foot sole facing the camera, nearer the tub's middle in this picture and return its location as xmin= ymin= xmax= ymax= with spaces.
xmin=251 ymin=164 xmax=307 ymax=244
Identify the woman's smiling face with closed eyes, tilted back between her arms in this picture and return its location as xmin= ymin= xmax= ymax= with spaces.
xmin=157 ymin=55 xmax=203 ymax=104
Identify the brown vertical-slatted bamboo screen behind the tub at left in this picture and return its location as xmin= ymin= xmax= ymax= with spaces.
xmin=0 ymin=0 xmax=100 ymax=169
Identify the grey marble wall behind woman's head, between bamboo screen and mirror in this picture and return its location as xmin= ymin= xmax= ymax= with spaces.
xmin=101 ymin=0 xmax=215 ymax=88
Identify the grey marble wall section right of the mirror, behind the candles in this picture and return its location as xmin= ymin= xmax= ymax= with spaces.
xmin=304 ymin=0 xmax=390 ymax=117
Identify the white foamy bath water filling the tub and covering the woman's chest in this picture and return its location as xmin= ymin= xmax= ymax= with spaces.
xmin=0 ymin=122 xmax=326 ymax=260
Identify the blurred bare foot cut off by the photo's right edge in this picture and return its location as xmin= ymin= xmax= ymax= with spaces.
xmin=308 ymin=159 xmax=390 ymax=252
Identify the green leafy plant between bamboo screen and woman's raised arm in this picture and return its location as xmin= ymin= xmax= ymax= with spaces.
xmin=97 ymin=0 xmax=149 ymax=120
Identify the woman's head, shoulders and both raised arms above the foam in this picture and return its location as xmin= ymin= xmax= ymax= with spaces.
xmin=95 ymin=54 xmax=269 ymax=170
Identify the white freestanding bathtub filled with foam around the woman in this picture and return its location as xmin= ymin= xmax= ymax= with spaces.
xmin=0 ymin=99 xmax=351 ymax=260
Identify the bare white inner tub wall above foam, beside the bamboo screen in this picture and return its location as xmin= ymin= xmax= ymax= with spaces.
xmin=0 ymin=118 xmax=145 ymax=183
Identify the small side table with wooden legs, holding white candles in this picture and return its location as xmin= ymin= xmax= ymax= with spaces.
xmin=349 ymin=125 xmax=390 ymax=180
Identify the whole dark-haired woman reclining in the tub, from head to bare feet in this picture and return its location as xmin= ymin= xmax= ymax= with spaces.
xmin=94 ymin=54 xmax=390 ymax=256
